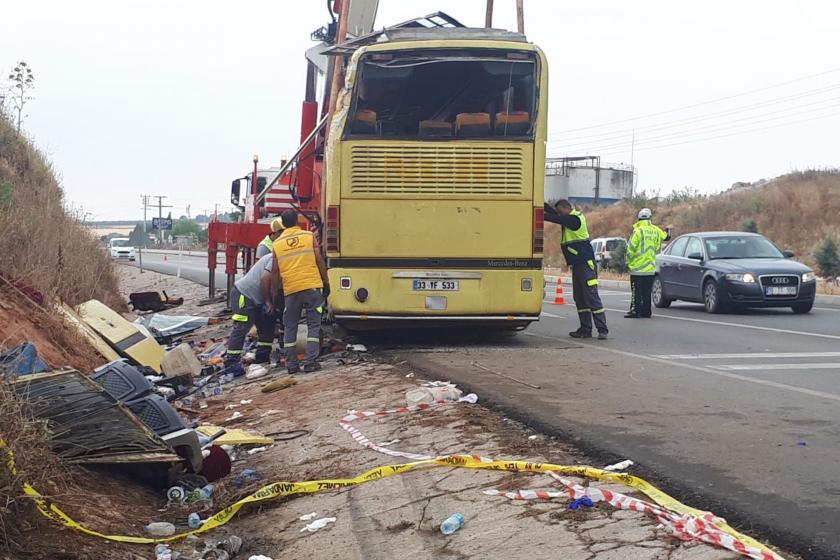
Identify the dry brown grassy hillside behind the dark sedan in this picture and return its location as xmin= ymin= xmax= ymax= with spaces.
xmin=546 ymin=169 xmax=840 ymax=266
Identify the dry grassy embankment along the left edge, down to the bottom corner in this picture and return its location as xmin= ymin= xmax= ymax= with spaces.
xmin=0 ymin=115 xmax=126 ymax=559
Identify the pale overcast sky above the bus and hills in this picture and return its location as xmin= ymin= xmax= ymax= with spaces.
xmin=0 ymin=0 xmax=840 ymax=220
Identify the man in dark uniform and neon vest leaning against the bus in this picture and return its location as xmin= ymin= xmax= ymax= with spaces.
xmin=545 ymin=199 xmax=609 ymax=340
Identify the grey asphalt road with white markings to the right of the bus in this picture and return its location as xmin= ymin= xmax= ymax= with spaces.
xmin=392 ymin=286 xmax=840 ymax=558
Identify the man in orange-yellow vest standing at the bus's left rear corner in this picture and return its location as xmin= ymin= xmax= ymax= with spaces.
xmin=274 ymin=210 xmax=330 ymax=373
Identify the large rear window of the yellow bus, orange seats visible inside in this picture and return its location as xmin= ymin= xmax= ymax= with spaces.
xmin=347 ymin=51 xmax=537 ymax=140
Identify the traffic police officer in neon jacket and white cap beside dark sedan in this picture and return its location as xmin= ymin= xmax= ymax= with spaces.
xmin=624 ymin=208 xmax=670 ymax=319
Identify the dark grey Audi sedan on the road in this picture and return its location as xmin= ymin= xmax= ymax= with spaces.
xmin=651 ymin=231 xmax=817 ymax=313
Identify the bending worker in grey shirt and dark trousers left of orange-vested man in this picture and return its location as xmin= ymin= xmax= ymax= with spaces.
xmin=225 ymin=253 xmax=275 ymax=367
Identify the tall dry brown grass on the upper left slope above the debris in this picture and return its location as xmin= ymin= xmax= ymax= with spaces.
xmin=0 ymin=112 xmax=125 ymax=309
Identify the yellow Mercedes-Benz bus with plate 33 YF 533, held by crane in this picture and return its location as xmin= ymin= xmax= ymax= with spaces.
xmin=323 ymin=28 xmax=548 ymax=329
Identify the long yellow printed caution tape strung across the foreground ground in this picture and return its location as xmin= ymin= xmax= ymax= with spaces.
xmin=0 ymin=439 xmax=775 ymax=554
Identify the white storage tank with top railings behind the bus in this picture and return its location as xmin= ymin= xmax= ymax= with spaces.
xmin=545 ymin=156 xmax=635 ymax=204
